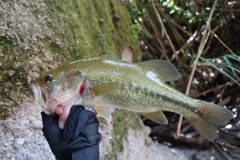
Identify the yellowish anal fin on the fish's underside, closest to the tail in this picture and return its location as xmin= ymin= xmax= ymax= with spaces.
xmin=139 ymin=110 xmax=168 ymax=124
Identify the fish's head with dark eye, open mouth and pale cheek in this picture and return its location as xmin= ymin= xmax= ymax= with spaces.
xmin=30 ymin=67 xmax=84 ymax=115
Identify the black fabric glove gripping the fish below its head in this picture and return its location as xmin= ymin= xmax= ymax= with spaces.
xmin=41 ymin=106 xmax=101 ymax=160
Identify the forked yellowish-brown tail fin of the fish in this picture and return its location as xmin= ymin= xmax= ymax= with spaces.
xmin=188 ymin=101 xmax=233 ymax=141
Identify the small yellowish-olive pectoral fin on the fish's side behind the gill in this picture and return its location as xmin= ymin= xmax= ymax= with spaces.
xmin=92 ymin=84 xmax=117 ymax=96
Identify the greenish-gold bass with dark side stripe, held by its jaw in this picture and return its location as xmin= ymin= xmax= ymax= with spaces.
xmin=31 ymin=55 xmax=233 ymax=141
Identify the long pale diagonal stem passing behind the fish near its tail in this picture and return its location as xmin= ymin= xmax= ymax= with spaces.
xmin=176 ymin=0 xmax=218 ymax=137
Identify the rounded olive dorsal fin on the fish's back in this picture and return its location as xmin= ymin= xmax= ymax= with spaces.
xmin=137 ymin=59 xmax=181 ymax=82
